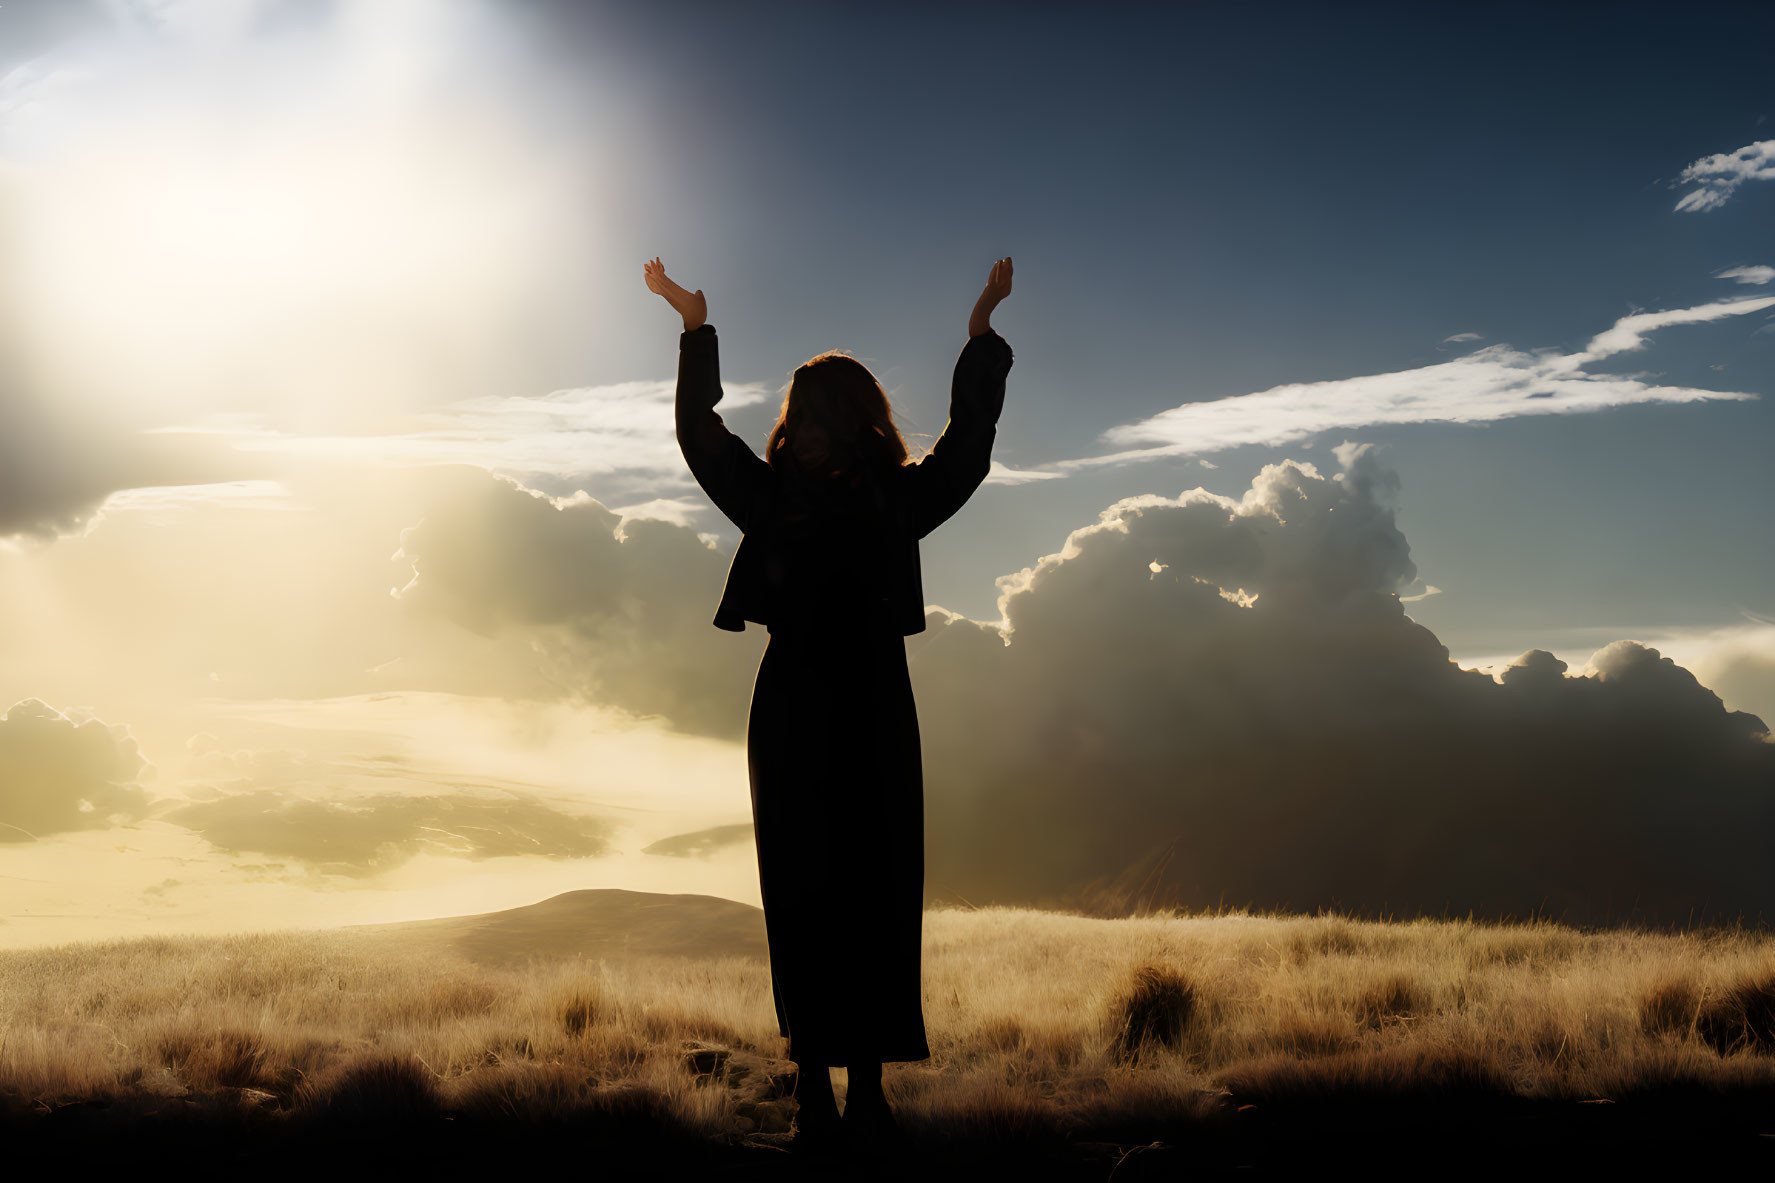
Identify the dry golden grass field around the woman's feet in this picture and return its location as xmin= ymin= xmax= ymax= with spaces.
xmin=0 ymin=908 xmax=1775 ymax=1179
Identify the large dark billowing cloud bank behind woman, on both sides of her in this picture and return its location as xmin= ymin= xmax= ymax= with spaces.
xmin=405 ymin=458 xmax=1775 ymax=922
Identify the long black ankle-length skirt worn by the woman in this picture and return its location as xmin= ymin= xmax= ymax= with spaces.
xmin=746 ymin=629 xmax=930 ymax=1066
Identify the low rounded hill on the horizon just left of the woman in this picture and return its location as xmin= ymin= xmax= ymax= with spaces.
xmin=351 ymin=888 xmax=767 ymax=966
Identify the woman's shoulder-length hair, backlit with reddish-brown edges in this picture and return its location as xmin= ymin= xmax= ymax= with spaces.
xmin=765 ymin=350 xmax=907 ymax=481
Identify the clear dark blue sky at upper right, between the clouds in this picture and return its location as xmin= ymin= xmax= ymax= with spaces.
xmin=539 ymin=5 xmax=1775 ymax=652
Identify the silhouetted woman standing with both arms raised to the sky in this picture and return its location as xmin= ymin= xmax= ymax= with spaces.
xmin=644 ymin=258 xmax=1012 ymax=1140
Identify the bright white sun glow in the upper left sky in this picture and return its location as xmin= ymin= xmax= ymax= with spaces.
xmin=0 ymin=4 xmax=595 ymax=419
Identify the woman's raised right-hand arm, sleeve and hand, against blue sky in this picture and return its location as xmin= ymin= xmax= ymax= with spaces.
xmin=907 ymin=258 xmax=1015 ymax=538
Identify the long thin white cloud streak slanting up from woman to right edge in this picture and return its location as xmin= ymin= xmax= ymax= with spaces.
xmin=1051 ymin=297 xmax=1775 ymax=471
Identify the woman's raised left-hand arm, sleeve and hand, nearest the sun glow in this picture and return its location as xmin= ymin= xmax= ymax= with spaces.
xmin=646 ymin=259 xmax=774 ymax=533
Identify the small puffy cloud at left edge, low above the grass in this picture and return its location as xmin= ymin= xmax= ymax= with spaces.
xmin=0 ymin=698 xmax=151 ymax=844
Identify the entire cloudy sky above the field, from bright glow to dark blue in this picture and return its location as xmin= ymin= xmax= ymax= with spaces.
xmin=0 ymin=0 xmax=1775 ymax=945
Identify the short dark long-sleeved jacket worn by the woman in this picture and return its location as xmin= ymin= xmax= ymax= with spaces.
xmin=676 ymin=325 xmax=1012 ymax=636
